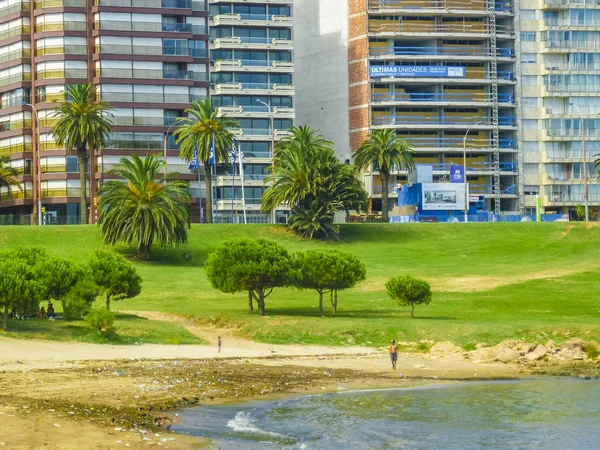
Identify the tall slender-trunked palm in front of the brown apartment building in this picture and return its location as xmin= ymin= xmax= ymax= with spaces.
xmin=52 ymin=83 xmax=112 ymax=223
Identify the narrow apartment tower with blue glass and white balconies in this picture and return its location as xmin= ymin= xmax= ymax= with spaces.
xmin=209 ymin=0 xmax=295 ymax=223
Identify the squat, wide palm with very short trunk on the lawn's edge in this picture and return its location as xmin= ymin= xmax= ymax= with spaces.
xmin=98 ymin=155 xmax=190 ymax=259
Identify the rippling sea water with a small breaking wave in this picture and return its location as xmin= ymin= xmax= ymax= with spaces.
xmin=174 ymin=378 xmax=600 ymax=450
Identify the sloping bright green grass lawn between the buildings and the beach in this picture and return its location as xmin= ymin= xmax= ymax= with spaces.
xmin=0 ymin=223 xmax=600 ymax=348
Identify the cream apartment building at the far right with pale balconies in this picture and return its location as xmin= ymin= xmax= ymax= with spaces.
xmin=519 ymin=0 xmax=600 ymax=219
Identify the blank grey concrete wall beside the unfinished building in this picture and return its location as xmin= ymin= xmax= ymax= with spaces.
xmin=294 ymin=0 xmax=350 ymax=161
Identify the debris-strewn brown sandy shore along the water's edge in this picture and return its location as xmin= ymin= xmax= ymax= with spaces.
xmin=0 ymin=352 xmax=597 ymax=449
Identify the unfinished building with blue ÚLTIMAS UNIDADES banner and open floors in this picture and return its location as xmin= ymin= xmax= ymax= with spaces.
xmin=296 ymin=0 xmax=519 ymax=213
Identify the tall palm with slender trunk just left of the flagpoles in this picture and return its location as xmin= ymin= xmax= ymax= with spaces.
xmin=173 ymin=99 xmax=240 ymax=223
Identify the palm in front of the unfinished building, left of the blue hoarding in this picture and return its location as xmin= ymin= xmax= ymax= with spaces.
xmin=354 ymin=129 xmax=414 ymax=222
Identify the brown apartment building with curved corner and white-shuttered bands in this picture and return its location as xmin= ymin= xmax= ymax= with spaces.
xmin=0 ymin=0 xmax=210 ymax=223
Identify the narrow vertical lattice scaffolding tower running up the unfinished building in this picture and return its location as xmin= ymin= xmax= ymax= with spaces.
xmin=488 ymin=0 xmax=500 ymax=214
